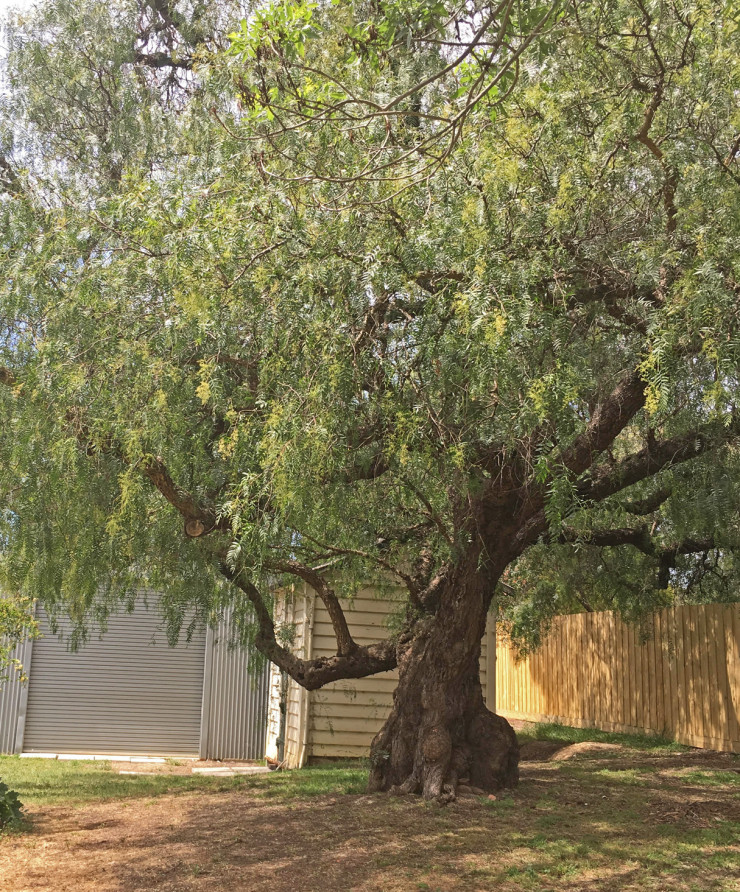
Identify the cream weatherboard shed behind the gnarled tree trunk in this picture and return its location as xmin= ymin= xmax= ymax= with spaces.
xmin=267 ymin=588 xmax=496 ymax=768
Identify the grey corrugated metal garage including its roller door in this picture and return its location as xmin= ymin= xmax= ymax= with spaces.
xmin=0 ymin=592 xmax=268 ymax=759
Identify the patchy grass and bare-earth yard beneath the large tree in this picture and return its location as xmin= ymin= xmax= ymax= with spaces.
xmin=0 ymin=726 xmax=740 ymax=892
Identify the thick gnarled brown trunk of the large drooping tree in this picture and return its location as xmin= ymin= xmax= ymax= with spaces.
xmin=369 ymin=556 xmax=519 ymax=802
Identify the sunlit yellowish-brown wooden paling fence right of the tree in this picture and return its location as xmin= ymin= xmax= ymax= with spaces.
xmin=496 ymin=604 xmax=740 ymax=752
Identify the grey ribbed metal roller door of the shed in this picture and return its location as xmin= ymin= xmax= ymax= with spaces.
xmin=23 ymin=603 xmax=206 ymax=756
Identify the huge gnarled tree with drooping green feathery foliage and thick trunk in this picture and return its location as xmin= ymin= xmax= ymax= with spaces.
xmin=0 ymin=0 xmax=740 ymax=801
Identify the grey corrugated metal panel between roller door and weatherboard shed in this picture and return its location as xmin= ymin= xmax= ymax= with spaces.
xmin=201 ymin=610 xmax=269 ymax=759
